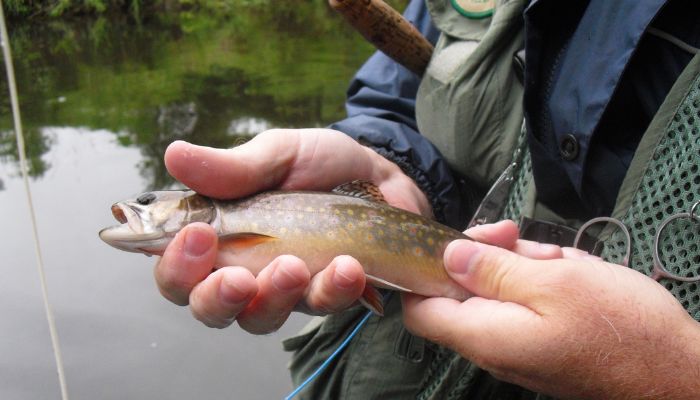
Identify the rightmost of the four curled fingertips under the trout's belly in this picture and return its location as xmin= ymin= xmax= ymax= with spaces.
xmin=306 ymin=256 xmax=365 ymax=314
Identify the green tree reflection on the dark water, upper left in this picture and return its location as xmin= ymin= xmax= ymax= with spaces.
xmin=0 ymin=5 xmax=370 ymax=188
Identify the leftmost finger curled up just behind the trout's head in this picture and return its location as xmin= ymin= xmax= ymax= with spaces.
xmin=154 ymin=223 xmax=217 ymax=306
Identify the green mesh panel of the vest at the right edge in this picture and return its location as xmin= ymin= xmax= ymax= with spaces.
xmin=602 ymin=77 xmax=700 ymax=320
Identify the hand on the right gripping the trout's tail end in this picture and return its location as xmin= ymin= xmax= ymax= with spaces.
xmin=403 ymin=221 xmax=700 ymax=399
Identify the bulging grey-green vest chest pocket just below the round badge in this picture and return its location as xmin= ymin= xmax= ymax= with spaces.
xmin=416 ymin=0 xmax=527 ymax=187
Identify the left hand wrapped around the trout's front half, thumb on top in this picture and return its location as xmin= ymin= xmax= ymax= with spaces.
xmin=154 ymin=129 xmax=430 ymax=334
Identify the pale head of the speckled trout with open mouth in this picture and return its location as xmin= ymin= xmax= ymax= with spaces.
xmin=99 ymin=190 xmax=216 ymax=255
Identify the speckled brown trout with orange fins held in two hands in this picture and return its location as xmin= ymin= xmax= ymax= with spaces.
xmin=99 ymin=181 xmax=471 ymax=315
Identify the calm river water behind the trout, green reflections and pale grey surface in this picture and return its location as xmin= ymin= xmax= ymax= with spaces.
xmin=0 ymin=7 xmax=378 ymax=399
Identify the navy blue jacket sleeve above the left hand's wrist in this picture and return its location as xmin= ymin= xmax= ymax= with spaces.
xmin=330 ymin=0 xmax=470 ymax=228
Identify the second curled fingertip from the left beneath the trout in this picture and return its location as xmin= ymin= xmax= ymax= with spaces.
xmin=190 ymin=267 xmax=258 ymax=328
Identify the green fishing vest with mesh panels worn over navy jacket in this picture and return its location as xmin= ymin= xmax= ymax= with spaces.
xmin=283 ymin=1 xmax=700 ymax=400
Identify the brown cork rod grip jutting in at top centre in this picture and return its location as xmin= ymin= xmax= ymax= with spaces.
xmin=328 ymin=0 xmax=433 ymax=76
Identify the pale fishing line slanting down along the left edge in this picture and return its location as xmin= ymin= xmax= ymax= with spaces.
xmin=0 ymin=0 xmax=68 ymax=400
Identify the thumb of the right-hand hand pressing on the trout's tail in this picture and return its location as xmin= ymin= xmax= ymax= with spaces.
xmin=444 ymin=240 xmax=547 ymax=304
